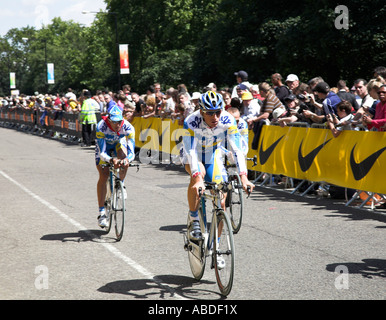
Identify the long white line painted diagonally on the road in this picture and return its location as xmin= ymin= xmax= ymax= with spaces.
xmin=0 ymin=170 xmax=185 ymax=300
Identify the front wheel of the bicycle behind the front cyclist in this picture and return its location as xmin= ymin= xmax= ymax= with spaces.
xmin=228 ymin=174 xmax=244 ymax=233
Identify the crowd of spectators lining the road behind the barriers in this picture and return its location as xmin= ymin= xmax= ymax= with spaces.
xmin=0 ymin=67 xmax=386 ymax=141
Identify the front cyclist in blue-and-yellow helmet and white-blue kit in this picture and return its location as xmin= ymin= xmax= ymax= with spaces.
xmin=180 ymin=91 xmax=254 ymax=240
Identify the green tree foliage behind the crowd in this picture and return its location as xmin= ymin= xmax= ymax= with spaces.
xmin=0 ymin=0 xmax=386 ymax=94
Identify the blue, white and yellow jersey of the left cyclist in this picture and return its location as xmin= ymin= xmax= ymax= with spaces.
xmin=95 ymin=119 xmax=135 ymax=165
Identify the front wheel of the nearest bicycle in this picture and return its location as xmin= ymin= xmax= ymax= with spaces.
xmin=213 ymin=210 xmax=235 ymax=296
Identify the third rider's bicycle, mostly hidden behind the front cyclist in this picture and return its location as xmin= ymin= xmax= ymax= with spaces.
xmin=225 ymin=156 xmax=257 ymax=234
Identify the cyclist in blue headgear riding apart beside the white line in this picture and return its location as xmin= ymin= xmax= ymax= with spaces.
xmin=95 ymin=105 xmax=135 ymax=228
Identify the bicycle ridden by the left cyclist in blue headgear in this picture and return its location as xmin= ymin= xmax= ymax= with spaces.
xmin=101 ymin=163 xmax=139 ymax=241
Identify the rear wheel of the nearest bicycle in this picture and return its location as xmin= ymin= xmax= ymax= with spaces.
xmin=187 ymin=200 xmax=206 ymax=280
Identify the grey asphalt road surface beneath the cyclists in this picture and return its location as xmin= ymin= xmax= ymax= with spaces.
xmin=0 ymin=128 xmax=386 ymax=301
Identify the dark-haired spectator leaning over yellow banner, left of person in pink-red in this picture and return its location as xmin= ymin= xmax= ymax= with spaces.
xmin=327 ymin=100 xmax=354 ymax=138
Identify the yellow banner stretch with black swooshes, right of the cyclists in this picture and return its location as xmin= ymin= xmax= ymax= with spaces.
xmin=248 ymin=126 xmax=386 ymax=194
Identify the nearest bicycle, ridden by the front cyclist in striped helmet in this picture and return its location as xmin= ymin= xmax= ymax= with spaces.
xmin=184 ymin=182 xmax=235 ymax=296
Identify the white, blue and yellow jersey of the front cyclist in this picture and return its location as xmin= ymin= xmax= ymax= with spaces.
xmin=181 ymin=110 xmax=247 ymax=181
